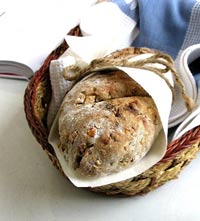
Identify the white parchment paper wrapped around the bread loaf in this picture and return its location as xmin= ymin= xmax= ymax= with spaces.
xmin=49 ymin=63 xmax=172 ymax=187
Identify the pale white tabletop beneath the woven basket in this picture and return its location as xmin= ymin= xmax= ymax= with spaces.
xmin=0 ymin=79 xmax=200 ymax=221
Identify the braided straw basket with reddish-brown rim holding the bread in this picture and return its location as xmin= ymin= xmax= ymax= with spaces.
xmin=24 ymin=27 xmax=200 ymax=196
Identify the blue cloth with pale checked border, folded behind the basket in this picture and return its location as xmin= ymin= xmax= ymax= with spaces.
xmin=112 ymin=0 xmax=200 ymax=127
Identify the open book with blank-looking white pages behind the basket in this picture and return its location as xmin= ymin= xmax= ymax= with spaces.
xmin=0 ymin=0 xmax=95 ymax=79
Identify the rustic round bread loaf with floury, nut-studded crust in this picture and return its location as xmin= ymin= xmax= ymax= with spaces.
xmin=59 ymin=70 xmax=161 ymax=177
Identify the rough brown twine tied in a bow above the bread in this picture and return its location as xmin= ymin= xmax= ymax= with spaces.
xmin=63 ymin=48 xmax=195 ymax=111
